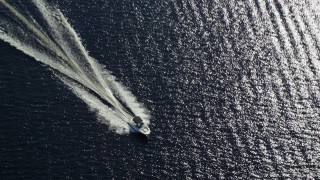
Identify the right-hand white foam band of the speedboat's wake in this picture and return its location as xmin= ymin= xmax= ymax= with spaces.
xmin=34 ymin=1 xmax=150 ymax=123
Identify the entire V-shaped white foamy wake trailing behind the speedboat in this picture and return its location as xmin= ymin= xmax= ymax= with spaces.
xmin=0 ymin=0 xmax=150 ymax=134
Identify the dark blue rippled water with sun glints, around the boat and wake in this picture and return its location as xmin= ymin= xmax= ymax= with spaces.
xmin=0 ymin=0 xmax=320 ymax=179
